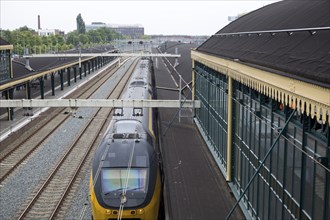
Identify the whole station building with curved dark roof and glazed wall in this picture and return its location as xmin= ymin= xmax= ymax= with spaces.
xmin=191 ymin=1 xmax=330 ymax=220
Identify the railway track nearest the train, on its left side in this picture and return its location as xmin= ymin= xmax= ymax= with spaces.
xmin=18 ymin=57 xmax=137 ymax=219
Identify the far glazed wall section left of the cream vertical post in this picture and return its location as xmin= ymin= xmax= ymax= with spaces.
xmin=195 ymin=65 xmax=228 ymax=168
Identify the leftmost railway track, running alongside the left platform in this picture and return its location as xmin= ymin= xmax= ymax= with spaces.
xmin=0 ymin=59 xmax=118 ymax=184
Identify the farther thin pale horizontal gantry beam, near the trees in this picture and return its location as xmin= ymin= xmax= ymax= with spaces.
xmin=23 ymin=53 xmax=181 ymax=58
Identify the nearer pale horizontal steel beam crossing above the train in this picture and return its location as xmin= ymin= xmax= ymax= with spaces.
xmin=0 ymin=99 xmax=201 ymax=108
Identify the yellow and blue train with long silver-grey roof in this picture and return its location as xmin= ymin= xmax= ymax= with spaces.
xmin=90 ymin=59 xmax=162 ymax=220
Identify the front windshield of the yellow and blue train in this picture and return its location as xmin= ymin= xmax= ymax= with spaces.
xmin=101 ymin=168 xmax=148 ymax=194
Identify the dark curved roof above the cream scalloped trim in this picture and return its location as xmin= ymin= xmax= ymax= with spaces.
xmin=197 ymin=0 xmax=330 ymax=88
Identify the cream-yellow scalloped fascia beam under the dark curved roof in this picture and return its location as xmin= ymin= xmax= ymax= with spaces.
xmin=191 ymin=50 xmax=330 ymax=124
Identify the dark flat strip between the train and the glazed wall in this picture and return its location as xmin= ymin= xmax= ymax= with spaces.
xmin=154 ymin=43 xmax=245 ymax=220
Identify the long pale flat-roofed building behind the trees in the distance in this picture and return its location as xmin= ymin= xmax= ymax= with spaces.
xmin=86 ymin=22 xmax=144 ymax=38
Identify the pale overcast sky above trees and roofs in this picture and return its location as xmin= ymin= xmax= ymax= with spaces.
xmin=0 ymin=0 xmax=278 ymax=35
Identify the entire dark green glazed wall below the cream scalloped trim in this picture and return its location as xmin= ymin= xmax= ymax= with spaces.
xmin=195 ymin=61 xmax=330 ymax=220
